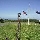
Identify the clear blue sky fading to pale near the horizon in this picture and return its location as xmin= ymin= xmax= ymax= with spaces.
xmin=0 ymin=0 xmax=40 ymax=19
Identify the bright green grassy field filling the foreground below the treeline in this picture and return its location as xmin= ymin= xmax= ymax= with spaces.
xmin=0 ymin=22 xmax=40 ymax=40
